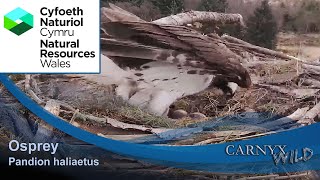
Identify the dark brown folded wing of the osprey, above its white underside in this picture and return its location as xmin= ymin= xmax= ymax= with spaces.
xmin=101 ymin=21 xmax=251 ymax=87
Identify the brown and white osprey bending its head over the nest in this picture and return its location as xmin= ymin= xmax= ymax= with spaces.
xmin=87 ymin=5 xmax=251 ymax=115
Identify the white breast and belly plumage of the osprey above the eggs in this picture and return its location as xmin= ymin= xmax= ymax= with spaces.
xmin=83 ymin=55 xmax=213 ymax=115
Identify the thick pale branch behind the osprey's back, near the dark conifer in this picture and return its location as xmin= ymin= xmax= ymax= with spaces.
xmin=153 ymin=11 xmax=245 ymax=27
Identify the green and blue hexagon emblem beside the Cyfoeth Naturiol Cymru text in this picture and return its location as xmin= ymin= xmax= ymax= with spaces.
xmin=4 ymin=7 xmax=33 ymax=36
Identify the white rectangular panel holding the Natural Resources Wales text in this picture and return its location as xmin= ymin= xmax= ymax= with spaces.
xmin=0 ymin=0 xmax=100 ymax=73
